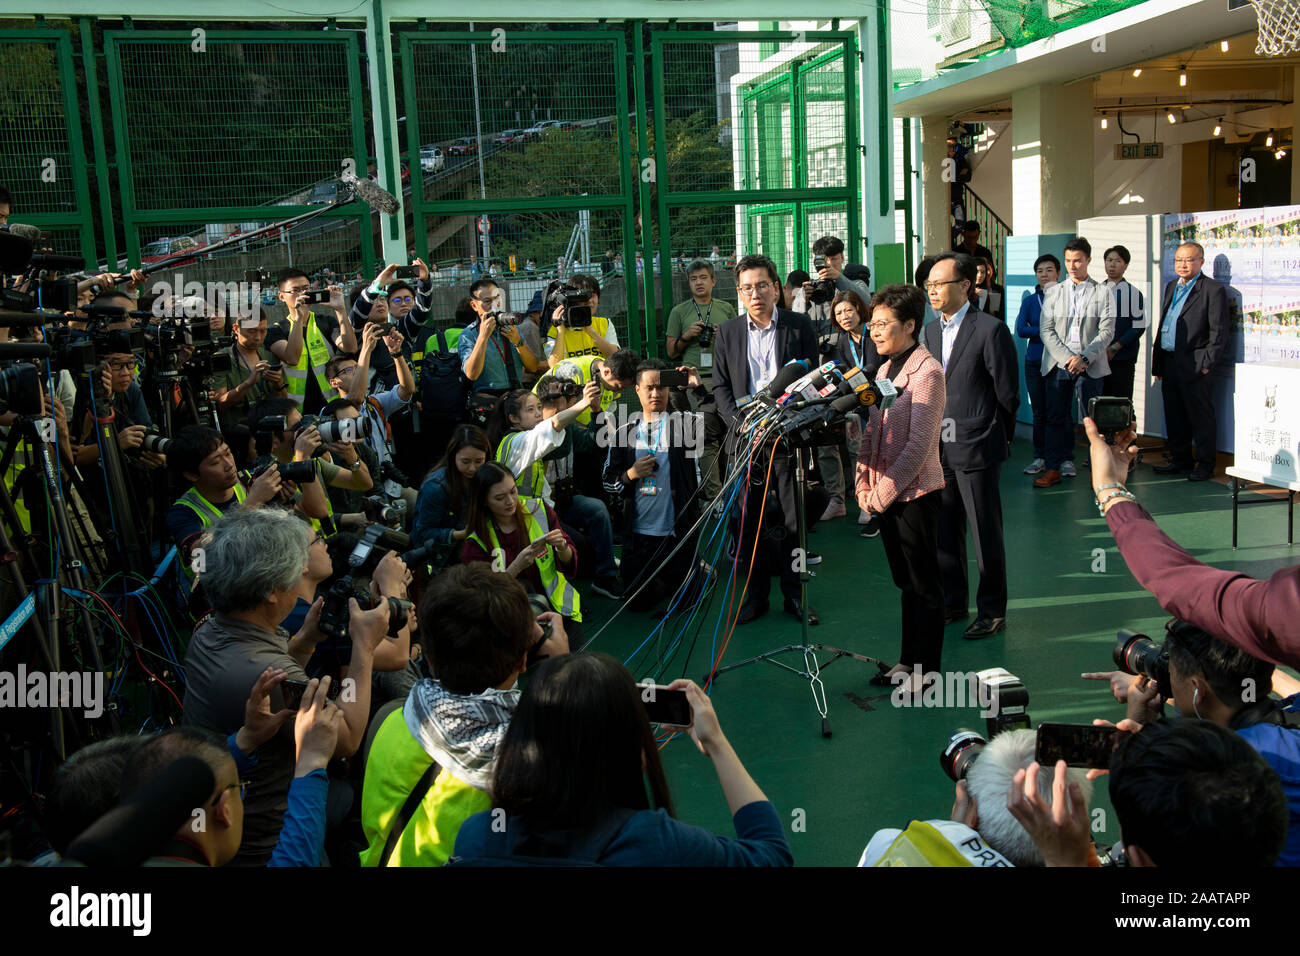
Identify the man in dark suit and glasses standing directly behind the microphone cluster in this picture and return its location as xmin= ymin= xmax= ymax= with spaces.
xmin=714 ymin=255 xmax=826 ymax=624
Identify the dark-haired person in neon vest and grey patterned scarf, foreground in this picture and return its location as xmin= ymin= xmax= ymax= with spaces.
xmin=361 ymin=564 xmax=568 ymax=866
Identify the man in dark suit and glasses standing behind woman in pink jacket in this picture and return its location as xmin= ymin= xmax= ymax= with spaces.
xmin=922 ymin=252 xmax=1021 ymax=640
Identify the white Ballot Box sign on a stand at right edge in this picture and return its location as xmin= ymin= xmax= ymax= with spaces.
xmin=1234 ymin=364 xmax=1300 ymax=484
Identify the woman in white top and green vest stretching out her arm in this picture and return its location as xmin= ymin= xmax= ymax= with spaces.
xmin=488 ymin=375 xmax=623 ymax=601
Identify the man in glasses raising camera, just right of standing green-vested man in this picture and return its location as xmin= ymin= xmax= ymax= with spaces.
xmin=326 ymin=325 xmax=416 ymax=512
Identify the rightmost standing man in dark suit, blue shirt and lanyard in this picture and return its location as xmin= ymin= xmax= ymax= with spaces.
xmin=1151 ymin=242 xmax=1231 ymax=481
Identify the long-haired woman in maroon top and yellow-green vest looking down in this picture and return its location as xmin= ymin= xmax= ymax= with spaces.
xmin=460 ymin=462 xmax=582 ymax=646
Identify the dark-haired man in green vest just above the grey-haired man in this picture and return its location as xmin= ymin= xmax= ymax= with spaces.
xmin=166 ymin=425 xmax=281 ymax=578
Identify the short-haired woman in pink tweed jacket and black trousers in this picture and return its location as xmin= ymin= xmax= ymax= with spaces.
xmin=857 ymin=285 xmax=945 ymax=693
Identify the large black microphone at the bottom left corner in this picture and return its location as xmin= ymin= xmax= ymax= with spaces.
xmin=64 ymin=757 xmax=217 ymax=869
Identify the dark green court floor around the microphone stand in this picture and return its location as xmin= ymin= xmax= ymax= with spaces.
xmin=584 ymin=441 xmax=1297 ymax=866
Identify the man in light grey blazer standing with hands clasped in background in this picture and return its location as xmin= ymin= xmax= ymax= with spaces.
xmin=1034 ymin=237 xmax=1115 ymax=488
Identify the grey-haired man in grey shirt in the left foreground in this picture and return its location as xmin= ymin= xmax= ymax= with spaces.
xmin=183 ymin=509 xmax=389 ymax=865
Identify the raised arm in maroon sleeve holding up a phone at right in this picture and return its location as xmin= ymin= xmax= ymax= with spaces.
xmin=1083 ymin=418 xmax=1300 ymax=667
